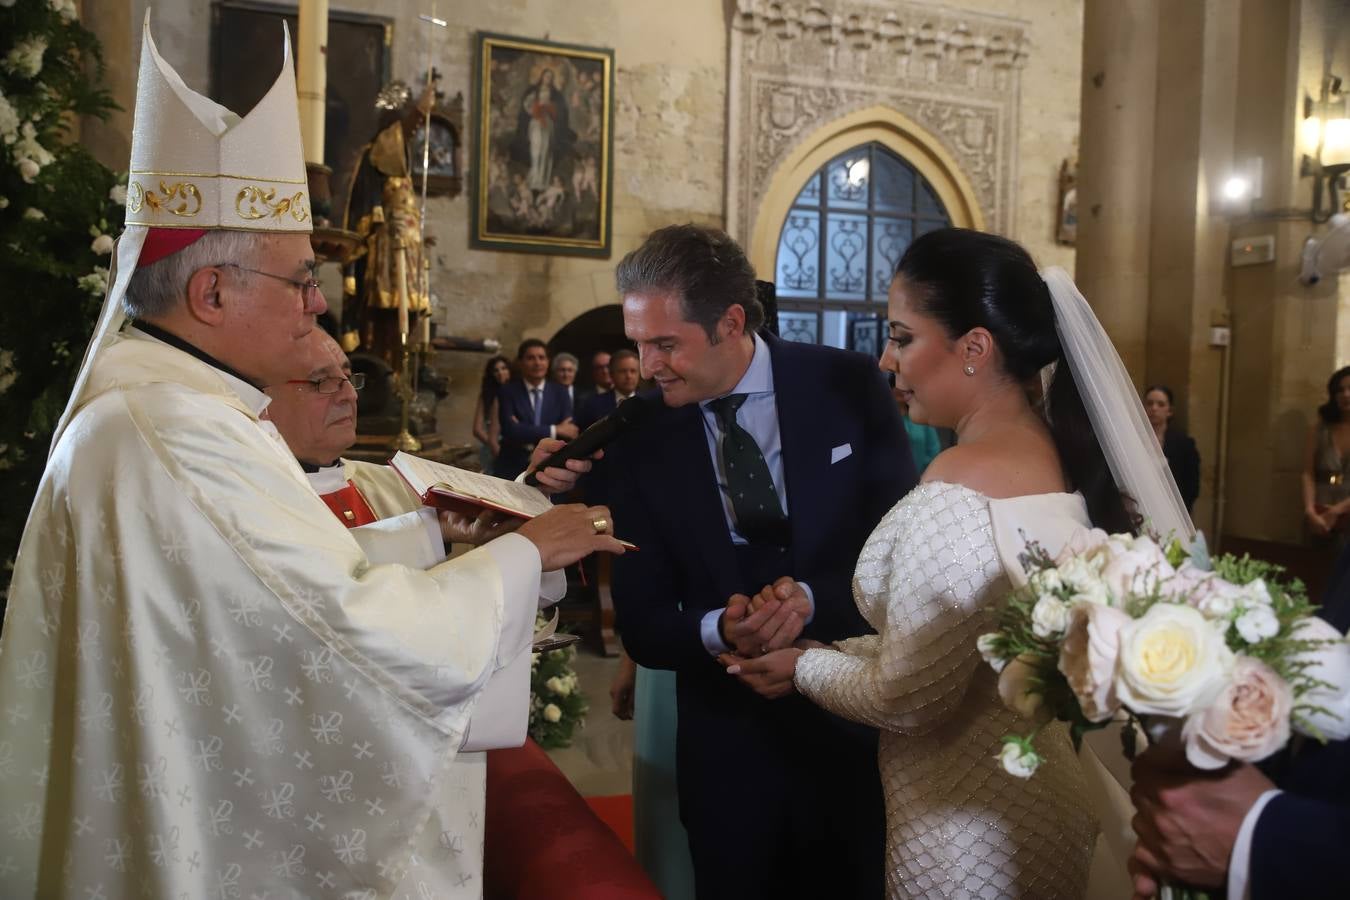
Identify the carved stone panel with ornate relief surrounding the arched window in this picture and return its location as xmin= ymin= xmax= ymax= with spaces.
xmin=726 ymin=0 xmax=1029 ymax=237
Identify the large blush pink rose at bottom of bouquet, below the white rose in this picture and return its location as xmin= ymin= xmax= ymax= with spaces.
xmin=1183 ymin=656 xmax=1293 ymax=769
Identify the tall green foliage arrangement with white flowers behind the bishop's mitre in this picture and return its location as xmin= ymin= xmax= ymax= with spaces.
xmin=0 ymin=0 xmax=126 ymax=599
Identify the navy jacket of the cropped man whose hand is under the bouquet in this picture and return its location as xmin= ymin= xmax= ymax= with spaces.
xmin=1247 ymin=549 xmax=1350 ymax=900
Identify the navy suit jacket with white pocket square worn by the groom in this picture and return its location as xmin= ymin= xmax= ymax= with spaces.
xmin=608 ymin=336 xmax=917 ymax=680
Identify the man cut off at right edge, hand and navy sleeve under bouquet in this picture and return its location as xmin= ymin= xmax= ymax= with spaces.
xmin=1130 ymin=551 xmax=1350 ymax=900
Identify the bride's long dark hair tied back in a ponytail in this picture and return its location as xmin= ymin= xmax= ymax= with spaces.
xmin=895 ymin=228 xmax=1138 ymax=532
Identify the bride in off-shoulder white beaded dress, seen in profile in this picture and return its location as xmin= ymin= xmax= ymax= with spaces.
xmin=725 ymin=229 xmax=1155 ymax=899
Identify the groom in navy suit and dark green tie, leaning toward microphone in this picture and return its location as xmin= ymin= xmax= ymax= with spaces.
xmin=606 ymin=225 xmax=915 ymax=900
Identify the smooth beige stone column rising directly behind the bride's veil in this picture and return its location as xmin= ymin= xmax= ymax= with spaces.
xmin=1076 ymin=0 xmax=1158 ymax=383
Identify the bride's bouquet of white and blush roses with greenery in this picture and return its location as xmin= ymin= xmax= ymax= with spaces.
xmin=979 ymin=530 xmax=1350 ymax=777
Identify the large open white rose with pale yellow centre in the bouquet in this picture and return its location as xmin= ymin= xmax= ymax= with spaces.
xmin=1115 ymin=603 xmax=1233 ymax=716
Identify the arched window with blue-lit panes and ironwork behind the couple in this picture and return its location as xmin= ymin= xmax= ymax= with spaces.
xmin=774 ymin=142 xmax=952 ymax=356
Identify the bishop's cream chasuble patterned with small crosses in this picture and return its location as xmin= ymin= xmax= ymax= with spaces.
xmin=0 ymin=336 xmax=540 ymax=900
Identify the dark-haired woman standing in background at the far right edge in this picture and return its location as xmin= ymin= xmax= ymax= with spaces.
xmin=1303 ymin=366 xmax=1350 ymax=544
